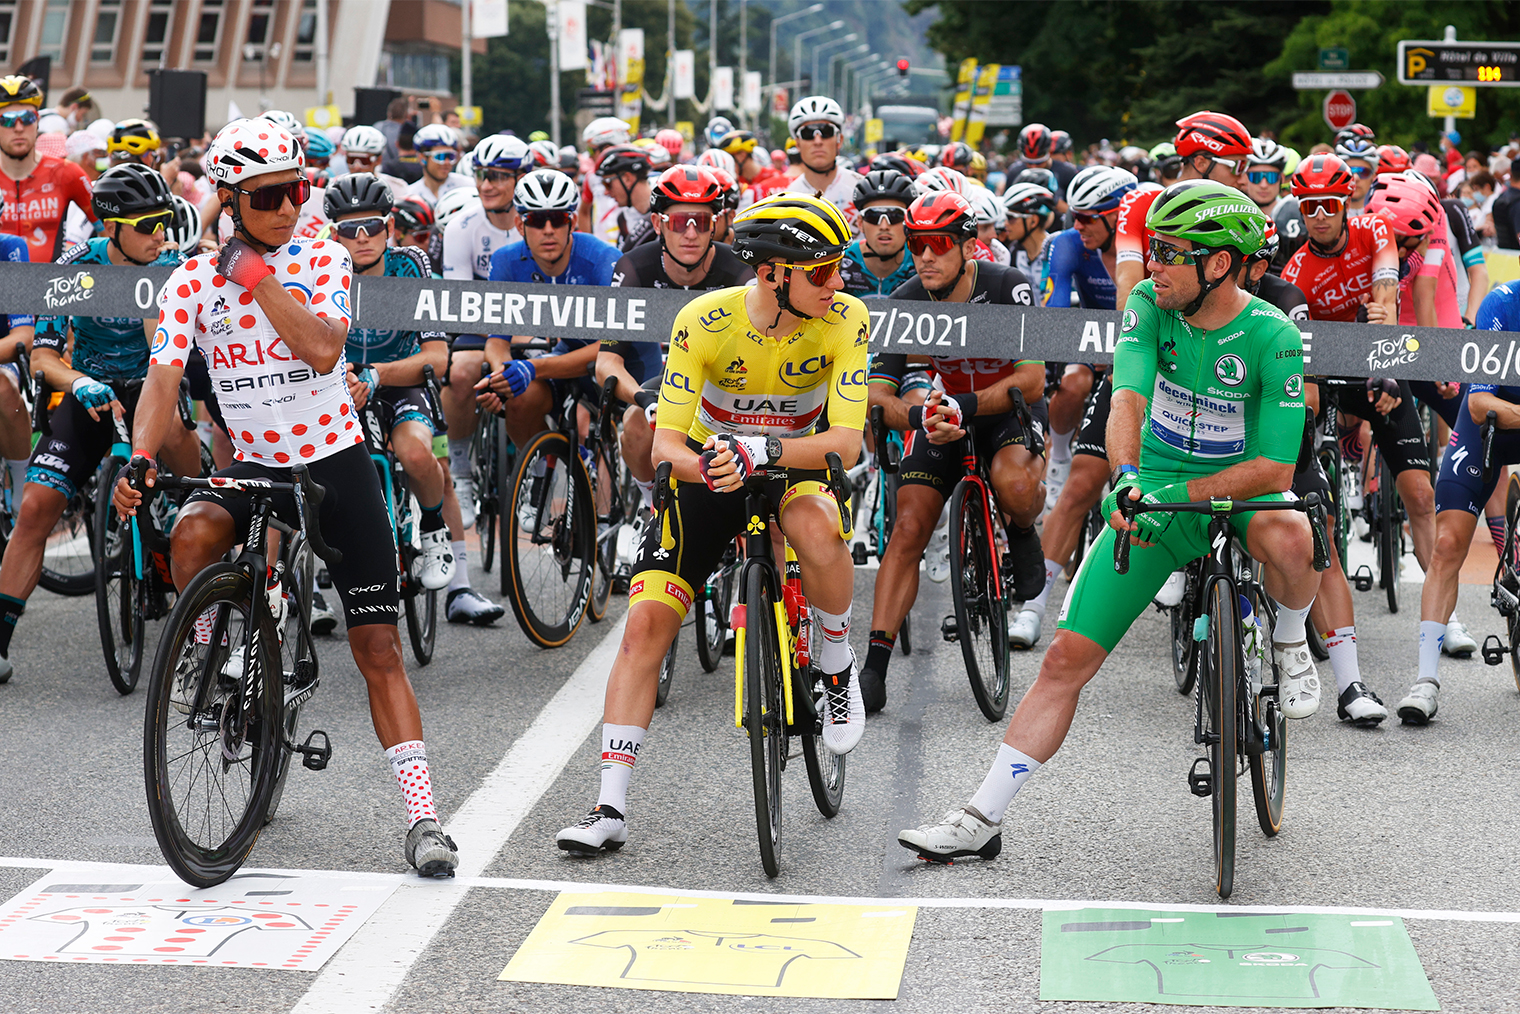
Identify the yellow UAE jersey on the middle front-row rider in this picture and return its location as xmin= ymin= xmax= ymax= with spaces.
xmin=655 ymin=286 xmax=871 ymax=444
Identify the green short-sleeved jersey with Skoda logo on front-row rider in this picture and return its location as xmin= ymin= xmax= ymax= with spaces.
xmin=1114 ymin=278 xmax=1304 ymax=482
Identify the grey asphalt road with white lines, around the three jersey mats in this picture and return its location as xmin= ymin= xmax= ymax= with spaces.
xmin=0 ymin=547 xmax=1520 ymax=1014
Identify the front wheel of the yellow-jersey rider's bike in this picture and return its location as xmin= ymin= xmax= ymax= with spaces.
xmin=743 ymin=562 xmax=787 ymax=877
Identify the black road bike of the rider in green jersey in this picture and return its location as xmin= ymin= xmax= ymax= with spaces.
xmin=1114 ymin=493 xmax=1330 ymax=898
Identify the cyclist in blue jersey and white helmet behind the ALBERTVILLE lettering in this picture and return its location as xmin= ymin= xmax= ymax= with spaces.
xmin=476 ymin=169 xmax=622 ymax=447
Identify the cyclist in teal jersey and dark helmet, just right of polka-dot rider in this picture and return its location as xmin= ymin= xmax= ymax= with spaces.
xmin=322 ymin=173 xmax=456 ymax=589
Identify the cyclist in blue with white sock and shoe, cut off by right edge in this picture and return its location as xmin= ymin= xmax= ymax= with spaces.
xmin=1398 ymin=281 xmax=1520 ymax=725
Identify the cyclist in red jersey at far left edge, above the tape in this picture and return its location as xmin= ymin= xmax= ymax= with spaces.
xmin=0 ymin=74 xmax=94 ymax=265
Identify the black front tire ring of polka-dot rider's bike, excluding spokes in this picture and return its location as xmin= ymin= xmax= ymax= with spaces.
xmin=143 ymin=562 xmax=284 ymax=888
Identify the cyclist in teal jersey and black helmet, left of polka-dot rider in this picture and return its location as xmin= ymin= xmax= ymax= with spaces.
xmin=0 ymin=163 xmax=201 ymax=683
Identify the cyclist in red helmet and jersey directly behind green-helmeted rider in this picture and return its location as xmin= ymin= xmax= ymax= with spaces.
xmin=1114 ymin=109 xmax=1251 ymax=306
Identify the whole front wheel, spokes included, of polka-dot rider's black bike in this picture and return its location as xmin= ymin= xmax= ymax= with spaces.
xmin=143 ymin=562 xmax=283 ymax=888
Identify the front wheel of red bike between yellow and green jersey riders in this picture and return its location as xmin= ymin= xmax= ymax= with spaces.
xmin=950 ymin=480 xmax=1008 ymax=722
